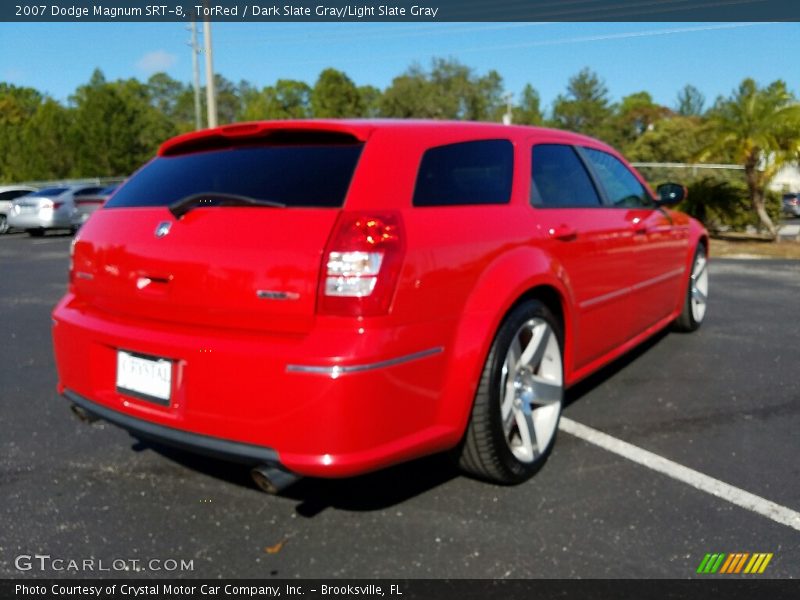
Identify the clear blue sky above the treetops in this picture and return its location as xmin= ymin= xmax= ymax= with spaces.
xmin=0 ymin=22 xmax=800 ymax=108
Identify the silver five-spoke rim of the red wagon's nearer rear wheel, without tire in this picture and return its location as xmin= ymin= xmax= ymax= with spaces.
xmin=499 ymin=318 xmax=564 ymax=463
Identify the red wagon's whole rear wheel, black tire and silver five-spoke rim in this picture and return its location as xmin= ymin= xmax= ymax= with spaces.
xmin=459 ymin=300 xmax=564 ymax=484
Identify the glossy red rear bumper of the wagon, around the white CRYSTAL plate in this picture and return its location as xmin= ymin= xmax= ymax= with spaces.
xmin=53 ymin=294 xmax=460 ymax=477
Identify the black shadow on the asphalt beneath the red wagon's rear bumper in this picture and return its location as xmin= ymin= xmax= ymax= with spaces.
xmin=132 ymin=439 xmax=461 ymax=517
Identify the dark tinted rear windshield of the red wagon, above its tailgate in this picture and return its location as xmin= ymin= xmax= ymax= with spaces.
xmin=105 ymin=143 xmax=363 ymax=208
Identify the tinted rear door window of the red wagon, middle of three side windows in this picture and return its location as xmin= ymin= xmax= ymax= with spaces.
xmin=531 ymin=144 xmax=601 ymax=208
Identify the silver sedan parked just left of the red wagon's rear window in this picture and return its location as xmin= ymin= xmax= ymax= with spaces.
xmin=8 ymin=185 xmax=103 ymax=236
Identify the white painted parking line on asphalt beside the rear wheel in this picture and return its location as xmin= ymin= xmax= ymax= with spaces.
xmin=559 ymin=417 xmax=800 ymax=531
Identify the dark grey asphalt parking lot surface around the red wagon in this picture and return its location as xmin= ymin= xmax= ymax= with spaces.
xmin=0 ymin=234 xmax=800 ymax=578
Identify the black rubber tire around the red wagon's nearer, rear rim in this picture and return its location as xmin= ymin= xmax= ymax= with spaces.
xmin=457 ymin=300 xmax=564 ymax=485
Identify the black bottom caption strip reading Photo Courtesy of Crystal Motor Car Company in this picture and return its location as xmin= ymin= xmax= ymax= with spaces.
xmin=0 ymin=575 xmax=800 ymax=600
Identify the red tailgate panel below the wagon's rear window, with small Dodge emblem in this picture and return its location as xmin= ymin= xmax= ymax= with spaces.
xmin=72 ymin=207 xmax=339 ymax=332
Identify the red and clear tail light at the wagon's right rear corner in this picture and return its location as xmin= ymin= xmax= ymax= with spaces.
xmin=317 ymin=212 xmax=405 ymax=317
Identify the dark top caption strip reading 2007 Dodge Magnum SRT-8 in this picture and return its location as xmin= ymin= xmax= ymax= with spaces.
xmin=0 ymin=0 xmax=800 ymax=23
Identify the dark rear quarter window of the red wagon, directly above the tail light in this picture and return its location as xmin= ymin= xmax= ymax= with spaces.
xmin=413 ymin=140 xmax=514 ymax=206
